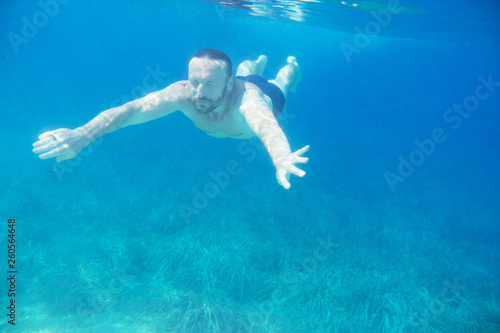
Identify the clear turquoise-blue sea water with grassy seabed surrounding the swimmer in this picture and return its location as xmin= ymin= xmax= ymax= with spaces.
xmin=0 ymin=0 xmax=500 ymax=333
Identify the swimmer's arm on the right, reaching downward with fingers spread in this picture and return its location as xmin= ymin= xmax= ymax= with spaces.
xmin=240 ymin=89 xmax=309 ymax=190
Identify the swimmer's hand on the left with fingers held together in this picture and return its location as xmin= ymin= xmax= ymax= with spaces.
xmin=33 ymin=128 xmax=92 ymax=162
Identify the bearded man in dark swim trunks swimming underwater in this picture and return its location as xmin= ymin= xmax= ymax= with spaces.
xmin=33 ymin=49 xmax=309 ymax=189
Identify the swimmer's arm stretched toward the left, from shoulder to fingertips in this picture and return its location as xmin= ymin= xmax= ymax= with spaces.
xmin=33 ymin=83 xmax=185 ymax=162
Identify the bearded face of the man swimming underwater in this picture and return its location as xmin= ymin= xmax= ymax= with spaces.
xmin=189 ymin=58 xmax=228 ymax=113
